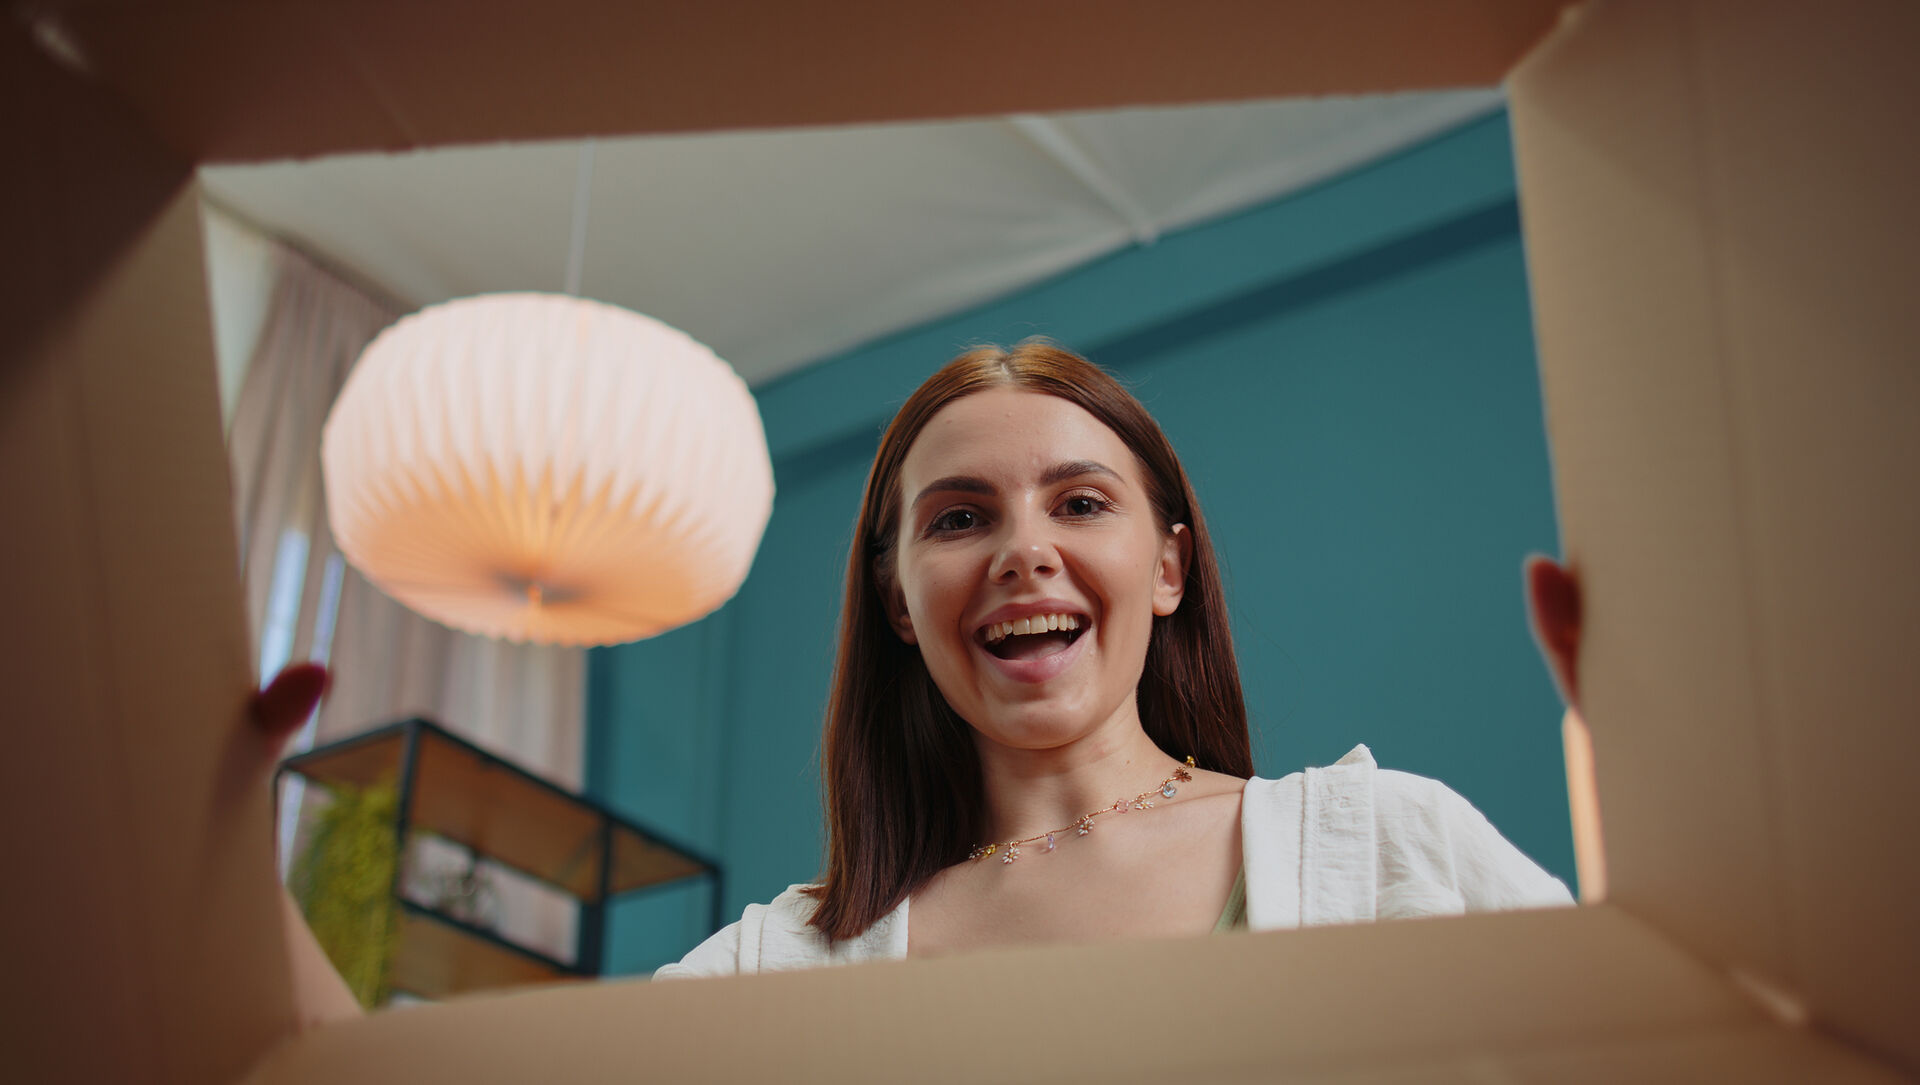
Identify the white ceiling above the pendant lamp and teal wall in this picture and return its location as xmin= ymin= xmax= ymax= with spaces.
xmin=202 ymin=90 xmax=1501 ymax=384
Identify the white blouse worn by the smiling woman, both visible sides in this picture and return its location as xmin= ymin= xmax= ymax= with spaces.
xmin=653 ymin=745 xmax=1572 ymax=979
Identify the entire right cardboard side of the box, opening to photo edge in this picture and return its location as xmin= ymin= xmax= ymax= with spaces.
xmin=1509 ymin=2 xmax=1920 ymax=1066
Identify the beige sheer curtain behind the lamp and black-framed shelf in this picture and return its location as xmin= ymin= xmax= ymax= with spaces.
xmin=228 ymin=237 xmax=586 ymax=958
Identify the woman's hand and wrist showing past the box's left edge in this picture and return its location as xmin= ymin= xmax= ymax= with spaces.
xmin=248 ymin=663 xmax=365 ymax=1031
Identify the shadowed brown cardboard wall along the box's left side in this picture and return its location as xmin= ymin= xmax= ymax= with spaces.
xmin=0 ymin=27 xmax=292 ymax=1081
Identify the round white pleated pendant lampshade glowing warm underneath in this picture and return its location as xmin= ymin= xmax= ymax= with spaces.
xmin=321 ymin=294 xmax=774 ymax=645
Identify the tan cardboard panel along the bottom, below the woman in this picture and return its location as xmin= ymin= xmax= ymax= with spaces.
xmin=240 ymin=908 xmax=1891 ymax=1085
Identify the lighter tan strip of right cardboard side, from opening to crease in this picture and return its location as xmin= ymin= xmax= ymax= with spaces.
xmin=1509 ymin=4 xmax=1786 ymax=976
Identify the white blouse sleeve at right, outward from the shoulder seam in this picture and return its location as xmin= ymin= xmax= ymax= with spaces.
xmin=1375 ymin=770 xmax=1572 ymax=918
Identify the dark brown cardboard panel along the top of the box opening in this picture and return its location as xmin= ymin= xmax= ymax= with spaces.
xmin=40 ymin=0 xmax=1559 ymax=161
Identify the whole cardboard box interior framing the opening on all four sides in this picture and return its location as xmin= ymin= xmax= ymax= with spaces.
xmin=0 ymin=0 xmax=1920 ymax=1083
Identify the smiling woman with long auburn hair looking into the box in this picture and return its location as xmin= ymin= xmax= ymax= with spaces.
xmin=655 ymin=340 xmax=1571 ymax=977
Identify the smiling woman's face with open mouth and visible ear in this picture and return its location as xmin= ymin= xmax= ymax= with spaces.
xmin=889 ymin=388 xmax=1188 ymax=749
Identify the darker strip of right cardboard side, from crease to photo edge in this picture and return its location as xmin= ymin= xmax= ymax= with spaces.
xmin=1699 ymin=0 xmax=1920 ymax=1066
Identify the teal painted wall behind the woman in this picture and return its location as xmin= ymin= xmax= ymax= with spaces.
xmin=588 ymin=115 xmax=1572 ymax=972
